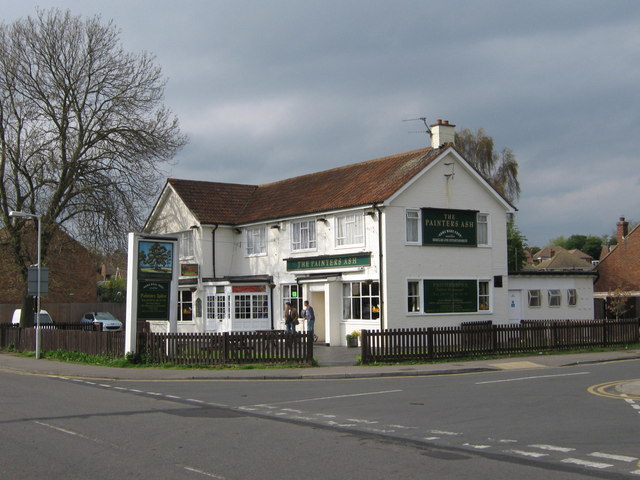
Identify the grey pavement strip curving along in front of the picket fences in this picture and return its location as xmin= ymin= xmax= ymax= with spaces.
xmin=0 ymin=345 xmax=640 ymax=396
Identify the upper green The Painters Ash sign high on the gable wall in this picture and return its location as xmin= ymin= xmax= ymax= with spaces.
xmin=422 ymin=208 xmax=478 ymax=247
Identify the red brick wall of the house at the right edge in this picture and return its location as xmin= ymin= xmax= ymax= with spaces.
xmin=594 ymin=227 xmax=640 ymax=292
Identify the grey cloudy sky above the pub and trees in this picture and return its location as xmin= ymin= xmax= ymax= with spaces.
xmin=0 ymin=0 xmax=640 ymax=246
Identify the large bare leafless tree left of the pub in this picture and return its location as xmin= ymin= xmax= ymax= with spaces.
xmin=0 ymin=9 xmax=187 ymax=318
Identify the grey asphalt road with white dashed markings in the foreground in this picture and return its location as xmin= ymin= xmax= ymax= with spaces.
xmin=0 ymin=360 xmax=640 ymax=480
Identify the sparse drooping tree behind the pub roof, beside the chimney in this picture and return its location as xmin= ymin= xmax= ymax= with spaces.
xmin=455 ymin=128 xmax=520 ymax=203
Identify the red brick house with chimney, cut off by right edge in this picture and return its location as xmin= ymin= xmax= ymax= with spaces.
xmin=594 ymin=217 xmax=640 ymax=318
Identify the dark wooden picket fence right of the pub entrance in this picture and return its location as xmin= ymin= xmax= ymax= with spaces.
xmin=361 ymin=319 xmax=640 ymax=364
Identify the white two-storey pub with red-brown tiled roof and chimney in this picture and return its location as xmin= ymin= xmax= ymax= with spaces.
xmin=144 ymin=121 xmax=515 ymax=345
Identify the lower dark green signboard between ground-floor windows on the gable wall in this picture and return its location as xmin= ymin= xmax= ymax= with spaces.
xmin=424 ymin=280 xmax=478 ymax=313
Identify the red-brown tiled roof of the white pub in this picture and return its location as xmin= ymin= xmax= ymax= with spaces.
xmin=168 ymin=145 xmax=442 ymax=225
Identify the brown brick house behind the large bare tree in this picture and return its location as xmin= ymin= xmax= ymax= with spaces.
xmin=0 ymin=224 xmax=97 ymax=308
